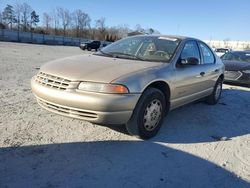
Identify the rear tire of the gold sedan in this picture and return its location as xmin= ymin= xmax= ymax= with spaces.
xmin=206 ymin=78 xmax=223 ymax=105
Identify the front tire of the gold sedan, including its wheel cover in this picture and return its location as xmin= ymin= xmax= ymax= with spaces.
xmin=126 ymin=88 xmax=166 ymax=139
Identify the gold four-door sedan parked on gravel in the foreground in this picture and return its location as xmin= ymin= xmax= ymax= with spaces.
xmin=31 ymin=35 xmax=224 ymax=139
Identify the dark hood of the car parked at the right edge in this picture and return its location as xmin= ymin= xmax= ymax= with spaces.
xmin=223 ymin=60 xmax=250 ymax=71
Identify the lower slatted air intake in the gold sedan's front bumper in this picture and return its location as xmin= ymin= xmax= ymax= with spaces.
xmin=37 ymin=99 xmax=98 ymax=119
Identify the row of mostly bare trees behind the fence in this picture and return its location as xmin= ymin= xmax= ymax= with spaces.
xmin=0 ymin=3 xmax=159 ymax=42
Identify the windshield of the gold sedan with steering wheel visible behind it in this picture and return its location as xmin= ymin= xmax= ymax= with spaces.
xmin=96 ymin=36 xmax=180 ymax=62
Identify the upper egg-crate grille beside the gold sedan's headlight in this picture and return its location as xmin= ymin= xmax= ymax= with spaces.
xmin=36 ymin=72 xmax=71 ymax=90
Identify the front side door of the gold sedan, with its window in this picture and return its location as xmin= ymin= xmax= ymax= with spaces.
xmin=171 ymin=40 xmax=207 ymax=108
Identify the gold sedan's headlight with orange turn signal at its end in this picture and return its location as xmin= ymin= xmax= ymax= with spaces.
xmin=78 ymin=82 xmax=129 ymax=94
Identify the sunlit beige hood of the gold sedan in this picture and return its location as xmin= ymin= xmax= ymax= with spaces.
xmin=40 ymin=55 xmax=163 ymax=83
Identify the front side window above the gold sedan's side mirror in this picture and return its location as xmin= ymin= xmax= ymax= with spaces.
xmin=181 ymin=41 xmax=201 ymax=62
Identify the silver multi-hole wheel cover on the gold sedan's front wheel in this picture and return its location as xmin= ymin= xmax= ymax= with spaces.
xmin=143 ymin=99 xmax=162 ymax=131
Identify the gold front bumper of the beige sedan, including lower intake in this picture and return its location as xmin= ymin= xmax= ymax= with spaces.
xmin=31 ymin=78 xmax=140 ymax=124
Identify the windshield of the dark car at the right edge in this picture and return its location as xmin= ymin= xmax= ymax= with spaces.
xmin=221 ymin=52 xmax=250 ymax=63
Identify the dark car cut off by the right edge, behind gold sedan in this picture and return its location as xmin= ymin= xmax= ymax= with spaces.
xmin=221 ymin=51 xmax=250 ymax=86
